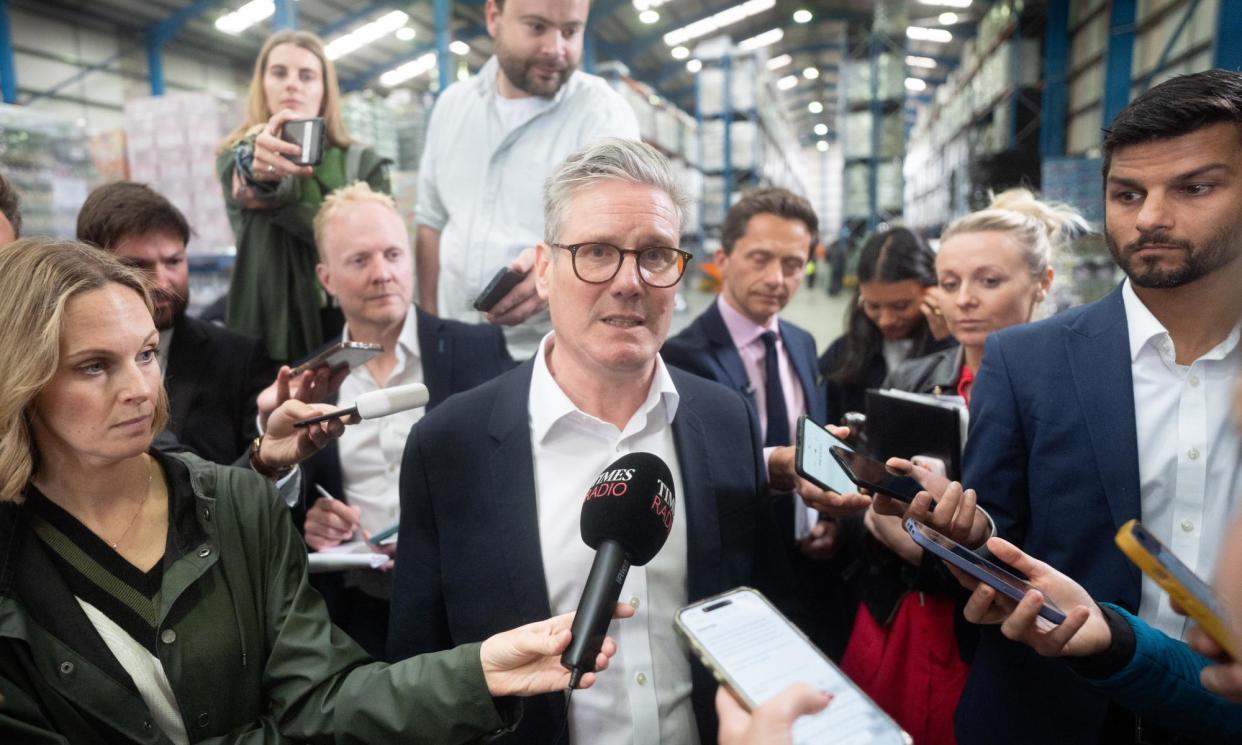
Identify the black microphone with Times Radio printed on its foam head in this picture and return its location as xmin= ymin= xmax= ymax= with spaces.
xmin=560 ymin=453 xmax=677 ymax=688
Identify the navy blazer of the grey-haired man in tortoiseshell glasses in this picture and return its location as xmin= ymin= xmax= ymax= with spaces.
xmin=388 ymin=361 xmax=796 ymax=745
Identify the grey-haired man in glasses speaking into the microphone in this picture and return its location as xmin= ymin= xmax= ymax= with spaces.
xmin=389 ymin=139 xmax=791 ymax=745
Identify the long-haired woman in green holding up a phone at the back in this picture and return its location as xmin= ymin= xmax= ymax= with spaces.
xmin=216 ymin=31 xmax=391 ymax=361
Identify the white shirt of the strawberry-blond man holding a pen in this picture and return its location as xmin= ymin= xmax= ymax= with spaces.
xmin=335 ymin=307 xmax=426 ymax=538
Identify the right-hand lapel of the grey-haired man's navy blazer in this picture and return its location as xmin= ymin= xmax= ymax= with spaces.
xmin=669 ymin=369 xmax=724 ymax=600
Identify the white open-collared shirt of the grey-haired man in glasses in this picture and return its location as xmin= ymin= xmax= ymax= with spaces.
xmin=529 ymin=334 xmax=698 ymax=745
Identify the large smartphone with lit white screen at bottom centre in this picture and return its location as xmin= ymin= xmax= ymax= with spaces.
xmin=677 ymin=587 xmax=908 ymax=745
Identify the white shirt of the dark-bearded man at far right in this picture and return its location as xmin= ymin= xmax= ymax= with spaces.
xmin=1122 ymin=279 xmax=1242 ymax=638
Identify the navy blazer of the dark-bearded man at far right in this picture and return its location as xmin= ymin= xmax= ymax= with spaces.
xmin=956 ymin=281 xmax=1141 ymax=745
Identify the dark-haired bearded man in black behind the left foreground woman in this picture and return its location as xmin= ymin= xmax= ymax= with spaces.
xmin=77 ymin=181 xmax=276 ymax=464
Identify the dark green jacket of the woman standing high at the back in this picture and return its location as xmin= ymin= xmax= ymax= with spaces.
xmin=216 ymin=144 xmax=392 ymax=363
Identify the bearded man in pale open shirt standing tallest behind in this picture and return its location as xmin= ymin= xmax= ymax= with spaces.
xmin=415 ymin=0 xmax=638 ymax=359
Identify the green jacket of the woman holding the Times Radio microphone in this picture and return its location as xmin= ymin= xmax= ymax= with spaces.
xmin=0 ymin=454 xmax=519 ymax=745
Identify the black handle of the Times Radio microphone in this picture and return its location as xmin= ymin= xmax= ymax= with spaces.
xmin=560 ymin=540 xmax=630 ymax=688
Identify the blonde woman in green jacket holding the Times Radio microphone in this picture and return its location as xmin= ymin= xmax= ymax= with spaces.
xmin=0 ymin=240 xmax=630 ymax=745
